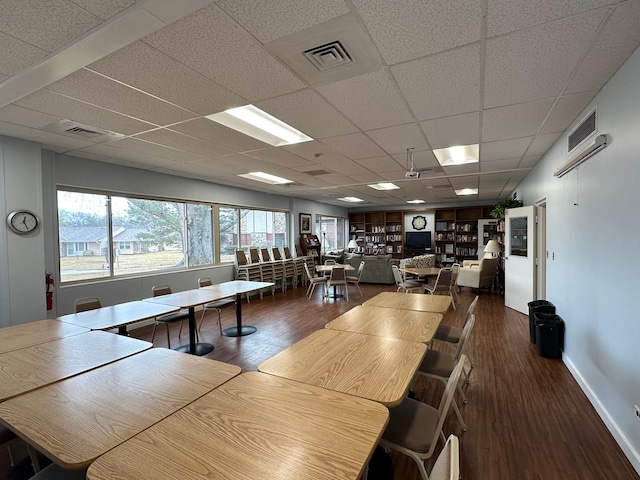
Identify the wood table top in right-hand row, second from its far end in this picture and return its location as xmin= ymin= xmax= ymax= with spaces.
xmin=325 ymin=305 xmax=442 ymax=343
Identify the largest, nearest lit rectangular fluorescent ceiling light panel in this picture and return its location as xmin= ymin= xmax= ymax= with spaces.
xmin=206 ymin=105 xmax=313 ymax=147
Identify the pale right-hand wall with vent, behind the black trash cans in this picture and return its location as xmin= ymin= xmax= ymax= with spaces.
xmin=517 ymin=45 xmax=640 ymax=473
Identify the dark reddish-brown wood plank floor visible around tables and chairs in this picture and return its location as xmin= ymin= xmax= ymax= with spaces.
xmin=0 ymin=285 xmax=640 ymax=480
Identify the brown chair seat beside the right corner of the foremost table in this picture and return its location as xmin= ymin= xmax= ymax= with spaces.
xmin=382 ymin=398 xmax=438 ymax=453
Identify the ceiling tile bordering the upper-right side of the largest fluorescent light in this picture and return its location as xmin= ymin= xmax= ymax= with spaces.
xmin=256 ymin=89 xmax=358 ymax=139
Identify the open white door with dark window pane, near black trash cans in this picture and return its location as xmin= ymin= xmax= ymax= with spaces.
xmin=504 ymin=206 xmax=537 ymax=315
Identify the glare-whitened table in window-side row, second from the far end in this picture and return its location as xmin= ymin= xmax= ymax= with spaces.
xmin=58 ymin=300 xmax=180 ymax=335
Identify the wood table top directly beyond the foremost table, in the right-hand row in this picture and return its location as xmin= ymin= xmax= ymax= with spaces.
xmin=258 ymin=329 xmax=427 ymax=407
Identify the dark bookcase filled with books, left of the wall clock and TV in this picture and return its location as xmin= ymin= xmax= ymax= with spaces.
xmin=349 ymin=211 xmax=403 ymax=258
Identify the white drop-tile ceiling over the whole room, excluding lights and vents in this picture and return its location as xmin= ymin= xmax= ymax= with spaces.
xmin=0 ymin=0 xmax=640 ymax=206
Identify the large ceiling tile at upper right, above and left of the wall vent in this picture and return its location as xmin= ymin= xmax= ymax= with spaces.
xmin=484 ymin=10 xmax=606 ymax=108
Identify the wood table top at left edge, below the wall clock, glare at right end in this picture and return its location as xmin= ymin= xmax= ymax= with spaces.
xmin=0 ymin=319 xmax=89 ymax=353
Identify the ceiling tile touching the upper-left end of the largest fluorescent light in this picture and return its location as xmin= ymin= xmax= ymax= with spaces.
xmin=87 ymin=42 xmax=247 ymax=115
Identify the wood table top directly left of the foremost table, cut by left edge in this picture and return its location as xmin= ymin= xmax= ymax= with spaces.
xmin=0 ymin=348 xmax=240 ymax=468
